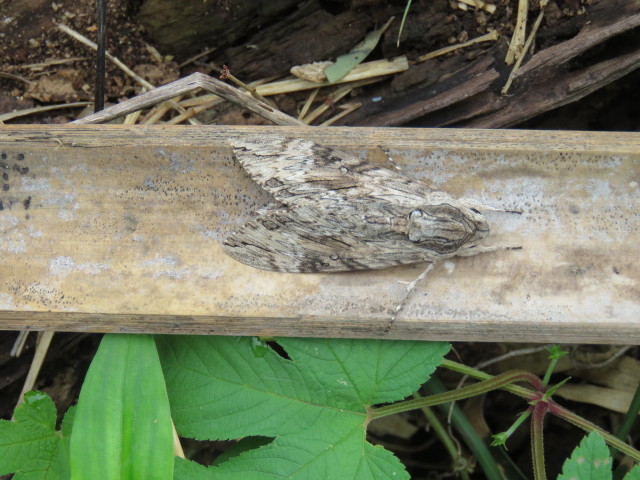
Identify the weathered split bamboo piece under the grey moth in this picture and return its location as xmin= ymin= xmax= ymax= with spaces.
xmin=0 ymin=125 xmax=640 ymax=344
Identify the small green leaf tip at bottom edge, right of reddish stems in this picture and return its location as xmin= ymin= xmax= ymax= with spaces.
xmin=558 ymin=432 xmax=612 ymax=480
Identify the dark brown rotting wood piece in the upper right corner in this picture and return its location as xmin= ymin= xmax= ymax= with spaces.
xmin=346 ymin=0 xmax=640 ymax=128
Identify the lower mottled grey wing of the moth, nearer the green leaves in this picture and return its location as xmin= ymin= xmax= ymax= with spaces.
xmin=223 ymin=209 xmax=435 ymax=273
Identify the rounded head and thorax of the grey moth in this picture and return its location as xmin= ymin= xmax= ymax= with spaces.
xmin=407 ymin=202 xmax=489 ymax=256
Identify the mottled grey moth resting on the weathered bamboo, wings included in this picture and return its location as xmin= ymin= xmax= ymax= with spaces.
xmin=223 ymin=135 xmax=496 ymax=273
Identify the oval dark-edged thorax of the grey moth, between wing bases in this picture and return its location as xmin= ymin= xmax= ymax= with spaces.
xmin=407 ymin=203 xmax=476 ymax=251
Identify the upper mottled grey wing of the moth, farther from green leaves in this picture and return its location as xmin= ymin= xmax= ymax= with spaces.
xmin=231 ymin=135 xmax=432 ymax=209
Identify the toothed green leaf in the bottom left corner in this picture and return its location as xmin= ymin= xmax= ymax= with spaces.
xmin=0 ymin=392 xmax=69 ymax=480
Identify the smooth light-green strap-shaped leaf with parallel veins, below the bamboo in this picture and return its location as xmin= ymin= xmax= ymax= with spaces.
xmin=71 ymin=335 xmax=174 ymax=480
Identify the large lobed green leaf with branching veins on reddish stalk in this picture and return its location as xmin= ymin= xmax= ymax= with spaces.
xmin=157 ymin=337 xmax=449 ymax=480
